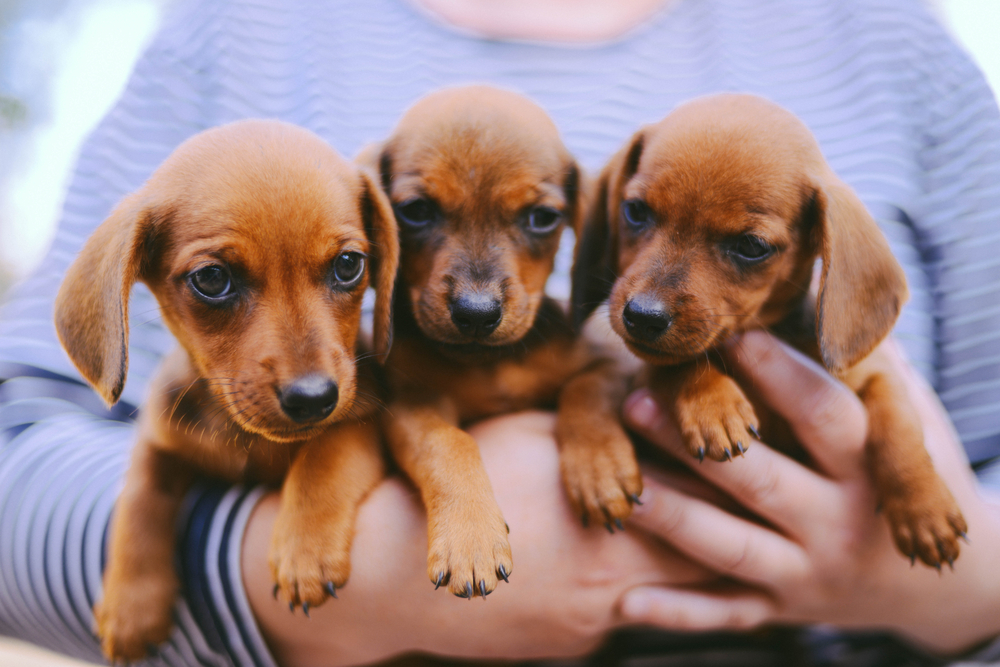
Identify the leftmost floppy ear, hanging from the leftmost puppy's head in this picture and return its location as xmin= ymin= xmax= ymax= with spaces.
xmin=55 ymin=192 xmax=155 ymax=406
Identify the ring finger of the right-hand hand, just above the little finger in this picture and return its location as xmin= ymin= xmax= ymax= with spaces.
xmin=629 ymin=479 xmax=808 ymax=589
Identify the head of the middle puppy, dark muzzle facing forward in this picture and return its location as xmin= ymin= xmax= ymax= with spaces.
xmin=368 ymin=86 xmax=581 ymax=346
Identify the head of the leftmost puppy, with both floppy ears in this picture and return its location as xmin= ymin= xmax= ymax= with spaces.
xmin=56 ymin=121 xmax=399 ymax=440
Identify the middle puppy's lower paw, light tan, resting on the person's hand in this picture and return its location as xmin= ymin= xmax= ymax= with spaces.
xmin=427 ymin=499 xmax=514 ymax=598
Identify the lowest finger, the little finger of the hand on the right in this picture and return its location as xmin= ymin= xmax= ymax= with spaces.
xmin=620 ymin=586 xmax=777 ymax=630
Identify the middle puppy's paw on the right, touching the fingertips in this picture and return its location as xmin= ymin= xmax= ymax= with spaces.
xmin=559 ymin=429 xmax=642 ymax=533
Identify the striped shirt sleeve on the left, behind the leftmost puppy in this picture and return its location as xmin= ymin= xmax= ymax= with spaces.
xmin=0 ymin=3 xmax=282 ymax=667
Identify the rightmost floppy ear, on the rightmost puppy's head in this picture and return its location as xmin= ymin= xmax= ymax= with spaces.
xmin=815 ymin=174 xmax=909 ymax=373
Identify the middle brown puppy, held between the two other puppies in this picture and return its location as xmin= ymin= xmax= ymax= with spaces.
xmin=368 ymin=86 xmax=641 ymax=598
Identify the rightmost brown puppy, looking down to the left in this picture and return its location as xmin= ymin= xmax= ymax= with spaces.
xmin=573 ymin=95 xmax=966 ymax=567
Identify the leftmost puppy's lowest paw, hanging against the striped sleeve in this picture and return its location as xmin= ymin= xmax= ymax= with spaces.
xmin=94 ymin=571 xmax=178 ymax=663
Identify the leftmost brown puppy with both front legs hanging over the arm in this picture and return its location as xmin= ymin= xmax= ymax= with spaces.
xmin=56 ymin=121 xmax=399 ymax=660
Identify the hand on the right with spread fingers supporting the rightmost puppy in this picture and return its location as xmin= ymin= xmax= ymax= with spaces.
xmin=621 ymin=332 xmax=1000 ymax=652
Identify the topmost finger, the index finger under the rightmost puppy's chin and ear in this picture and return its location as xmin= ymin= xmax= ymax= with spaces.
xmin=726 ymin=331 xmax=868 ymax=479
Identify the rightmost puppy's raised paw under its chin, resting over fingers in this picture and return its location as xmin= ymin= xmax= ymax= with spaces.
xmin=674 ymin=375 xmax=760 ymax=461
